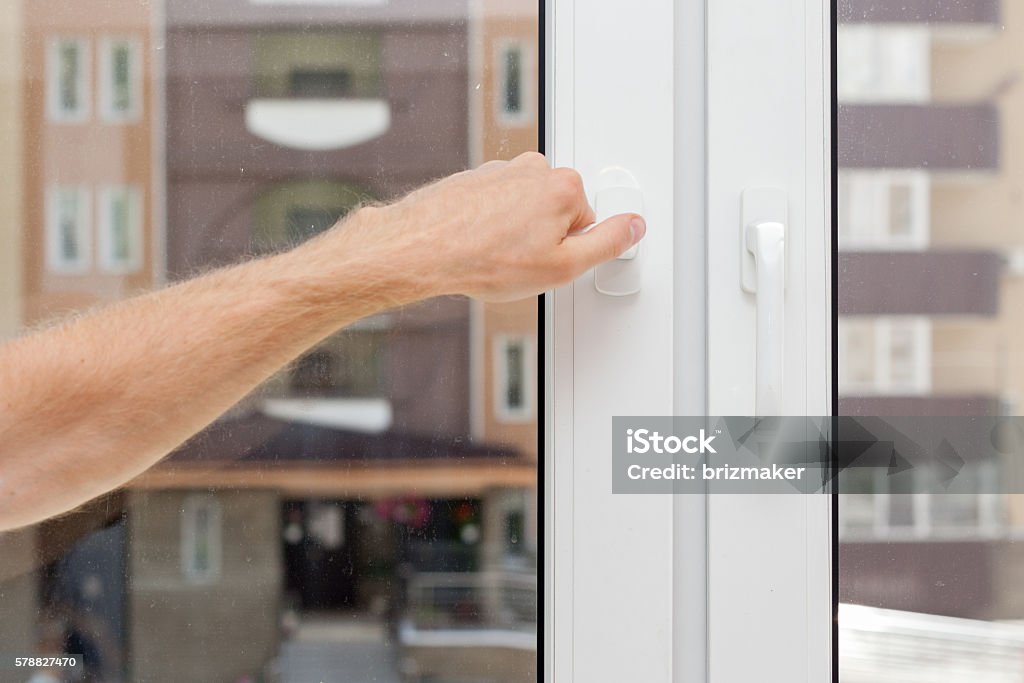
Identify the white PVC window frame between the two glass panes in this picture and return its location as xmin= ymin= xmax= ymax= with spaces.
xmin=544 ymin=0 xmax=834 ymax=683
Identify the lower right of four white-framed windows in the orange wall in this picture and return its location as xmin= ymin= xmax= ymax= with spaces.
xmin=99 ymin=185 xmax=142 ymax=273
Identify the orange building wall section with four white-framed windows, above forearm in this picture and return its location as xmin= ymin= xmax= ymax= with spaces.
xmin=22 ymin=0 xmax=163 ymax=325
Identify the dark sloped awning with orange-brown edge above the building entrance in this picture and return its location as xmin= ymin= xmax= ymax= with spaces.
xmin=128 ymin=414 xmax=538 ymax=498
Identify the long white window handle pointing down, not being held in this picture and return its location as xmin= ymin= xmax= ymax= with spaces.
xmin=742 ymin=188 xmax=787 ymax=417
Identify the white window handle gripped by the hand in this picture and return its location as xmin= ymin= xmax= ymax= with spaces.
xmin=594 ymin=166 xmax=638 ymax=296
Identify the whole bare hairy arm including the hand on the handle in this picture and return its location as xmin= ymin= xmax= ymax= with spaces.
xmin=0 ymin=154 xmax=644 ymax=530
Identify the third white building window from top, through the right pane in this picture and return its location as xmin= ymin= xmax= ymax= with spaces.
xmin=839 ymin=316 xmax=932 ymax=395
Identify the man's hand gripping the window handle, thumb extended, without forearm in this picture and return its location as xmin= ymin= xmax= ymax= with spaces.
xmin=329 ymin=152 xmax=646 ymax=301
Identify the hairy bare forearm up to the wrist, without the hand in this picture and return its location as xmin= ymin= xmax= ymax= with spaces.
xmin=0 ymin=209 xmax=428 ymax=528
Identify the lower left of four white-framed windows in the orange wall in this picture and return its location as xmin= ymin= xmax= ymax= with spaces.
xmin=46 ymin=185 xmax=92 ymax=273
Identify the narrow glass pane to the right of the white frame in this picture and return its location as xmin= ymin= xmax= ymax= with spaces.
xmin=837 ymin=0 xmax=1024 ymax=683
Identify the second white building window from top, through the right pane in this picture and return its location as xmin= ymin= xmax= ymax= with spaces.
xmin=839 ymin=171 xmax=931 ymax=251
